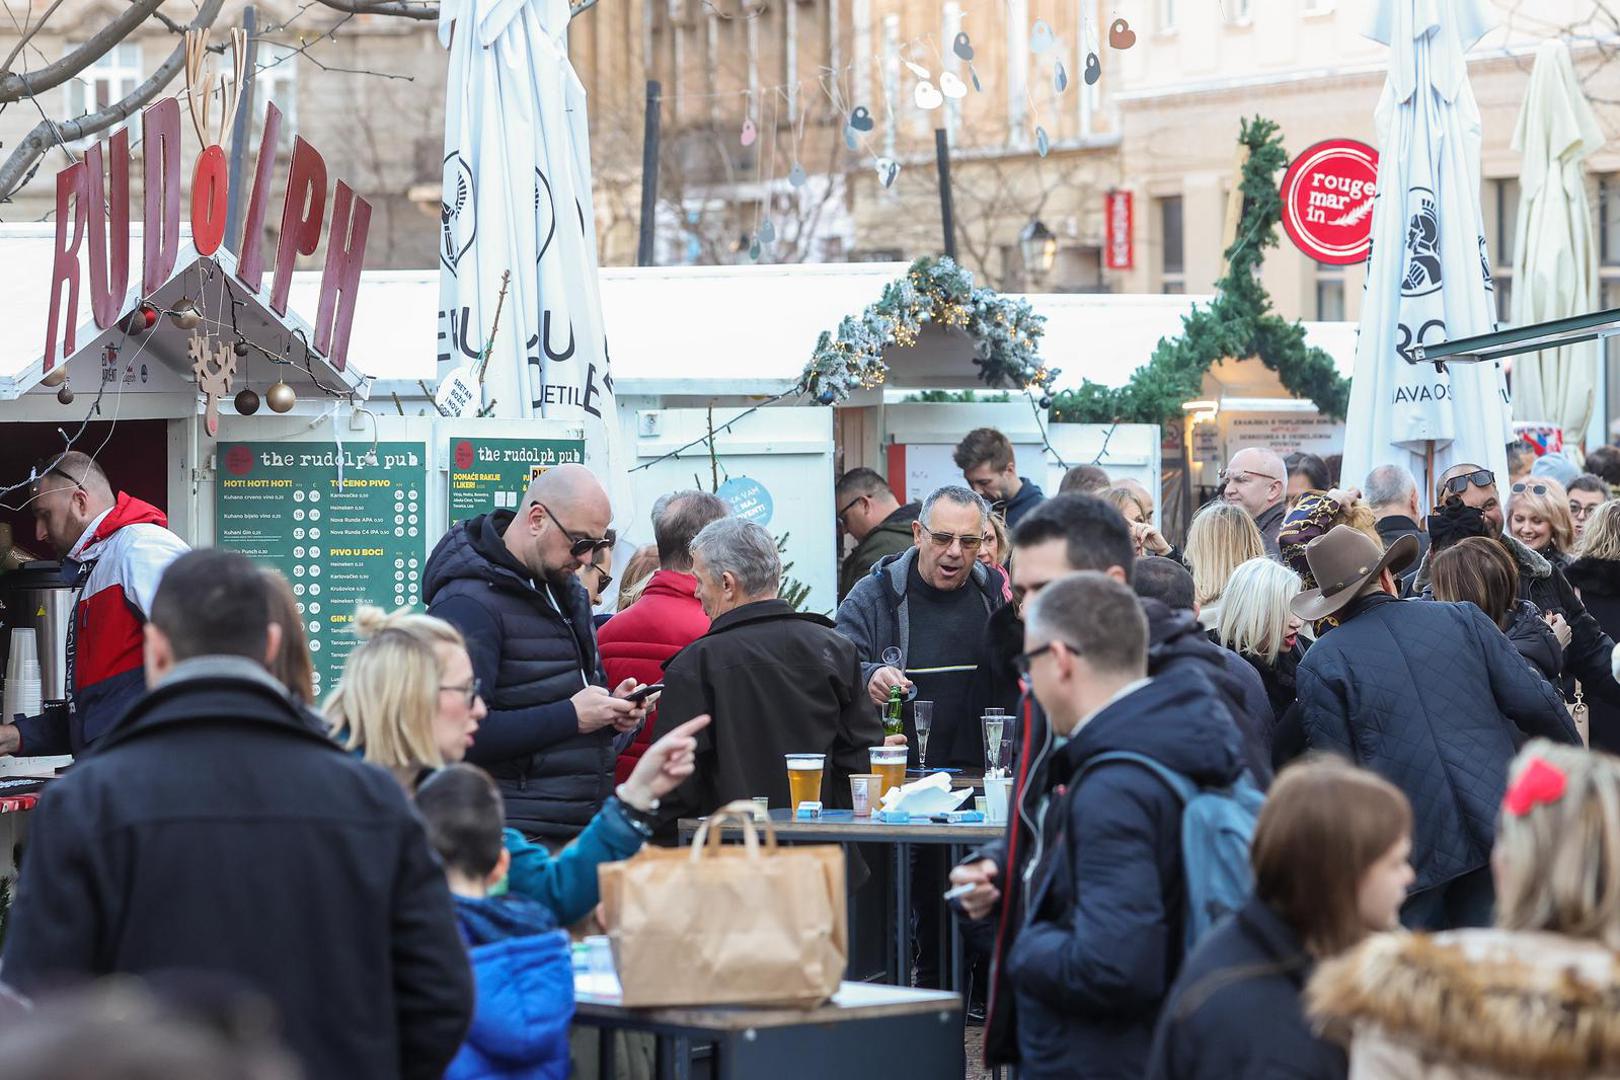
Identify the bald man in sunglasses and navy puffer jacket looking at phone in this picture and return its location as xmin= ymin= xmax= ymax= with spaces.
xmin=423 ymin=465 xmax=646 ymax=847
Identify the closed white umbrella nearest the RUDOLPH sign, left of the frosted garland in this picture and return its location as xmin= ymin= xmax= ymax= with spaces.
xmin=439 ymin=0 xmax=630 ymax=508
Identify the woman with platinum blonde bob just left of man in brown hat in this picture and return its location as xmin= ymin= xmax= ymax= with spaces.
xmin=1217 ymin=557 xmax=1307 ymax=737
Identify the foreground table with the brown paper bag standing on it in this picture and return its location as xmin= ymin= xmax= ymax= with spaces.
xmin=573 ymin=973 xmax=967 ymax=1080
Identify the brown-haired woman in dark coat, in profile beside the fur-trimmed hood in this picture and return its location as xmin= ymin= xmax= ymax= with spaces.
xmin=1147 ymin=758 xmax=1413 ymax=1080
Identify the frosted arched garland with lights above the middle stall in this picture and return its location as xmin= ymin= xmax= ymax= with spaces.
xmin=799 ymin=256 xmax=1058 ymax=406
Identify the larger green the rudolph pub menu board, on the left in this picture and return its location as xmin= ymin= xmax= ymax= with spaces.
xmin=214 ymin=442 xmax=429 ymax=698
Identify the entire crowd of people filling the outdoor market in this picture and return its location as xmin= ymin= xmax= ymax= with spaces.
xmin=0 ymin=429 xmax=1620 ymax=1080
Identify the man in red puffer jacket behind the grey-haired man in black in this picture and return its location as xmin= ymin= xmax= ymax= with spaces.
xmin=596 ymin=491 xmax=731 ymax=784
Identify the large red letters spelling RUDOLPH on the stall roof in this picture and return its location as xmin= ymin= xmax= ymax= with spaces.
xmin=44 ymin=97 xmax=371 ymax=371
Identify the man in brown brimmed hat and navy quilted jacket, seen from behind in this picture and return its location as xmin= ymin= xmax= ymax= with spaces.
xmin=1293 ymin=525 xmax=1580 ymax=929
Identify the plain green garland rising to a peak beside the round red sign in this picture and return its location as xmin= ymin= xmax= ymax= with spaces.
xmin=1051 ymin=117 xmax=1349 ymax=424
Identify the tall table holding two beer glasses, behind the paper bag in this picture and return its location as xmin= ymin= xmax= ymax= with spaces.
xmin=679 ymin=808 xmax=1006 ymax=991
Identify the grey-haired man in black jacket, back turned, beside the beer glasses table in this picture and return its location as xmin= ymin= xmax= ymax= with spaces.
xmin=654 ymin=518 xmax=885 ymax=839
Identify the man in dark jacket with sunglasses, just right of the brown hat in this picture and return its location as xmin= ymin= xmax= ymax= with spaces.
xmin=1413 ymin=463 xmax=1620 ymax=704
